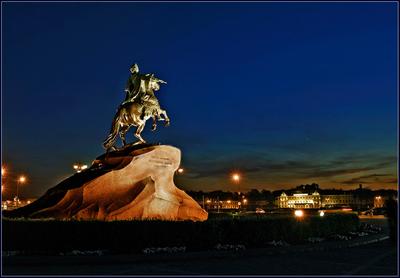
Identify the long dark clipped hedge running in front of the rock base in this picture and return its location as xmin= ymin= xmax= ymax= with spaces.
xmin=2 ymin=214 xmax=359 ymax=253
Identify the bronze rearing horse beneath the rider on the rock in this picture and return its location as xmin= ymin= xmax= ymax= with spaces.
xmin=103 ymin=78 xmax=170 ymax=151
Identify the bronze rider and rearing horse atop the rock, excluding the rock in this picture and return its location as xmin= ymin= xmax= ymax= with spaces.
xmin=103 ymin=64 xmax=170 ymax=151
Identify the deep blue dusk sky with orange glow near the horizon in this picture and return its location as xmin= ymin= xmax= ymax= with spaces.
xmin=2 ymin=2 xmax=397 ymax=197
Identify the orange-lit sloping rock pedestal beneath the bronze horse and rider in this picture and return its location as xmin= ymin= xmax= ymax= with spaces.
xmin=4 ymin=145 xmax=208 ymax=221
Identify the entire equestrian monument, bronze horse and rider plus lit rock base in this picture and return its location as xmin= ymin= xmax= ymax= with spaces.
xmin=2 ymin=64 xmax=208 ymax=222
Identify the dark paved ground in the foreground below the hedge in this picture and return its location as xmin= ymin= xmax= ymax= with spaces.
xmin=3 ymin=219 xmax=398 ymax=276
